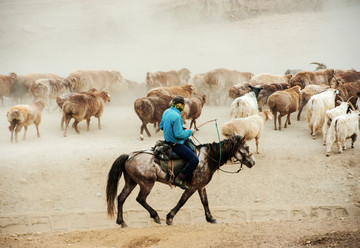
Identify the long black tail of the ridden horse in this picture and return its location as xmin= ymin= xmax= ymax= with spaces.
xmin=106 ymin=154 xmax=129 ymax=217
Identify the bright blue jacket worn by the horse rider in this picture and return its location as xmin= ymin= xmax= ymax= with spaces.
xmin=160 ymin=107 xmax=192 ymax=144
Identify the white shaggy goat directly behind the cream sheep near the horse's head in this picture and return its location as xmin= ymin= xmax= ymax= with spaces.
xmin=230 ymin=85 xmax=262 ymax=119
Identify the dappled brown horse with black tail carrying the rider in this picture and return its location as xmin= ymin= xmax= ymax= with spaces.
xmin=106 ymin=136 xmax=255 ymax=227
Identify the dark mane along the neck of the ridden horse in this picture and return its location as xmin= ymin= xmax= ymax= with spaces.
xmin=196 ymin=135 xmax=245 ymax=171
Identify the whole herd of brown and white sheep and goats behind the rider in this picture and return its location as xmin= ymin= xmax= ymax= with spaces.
xmin=0 ymin=64 xmax=360 ymax=156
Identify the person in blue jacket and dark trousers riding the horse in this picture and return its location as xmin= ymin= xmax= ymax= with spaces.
xmin=160 ymin=96 xmax=199 ymax=189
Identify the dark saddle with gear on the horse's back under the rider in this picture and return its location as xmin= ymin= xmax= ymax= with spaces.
xmin=153 ymin=139 xmax=195 ymax=182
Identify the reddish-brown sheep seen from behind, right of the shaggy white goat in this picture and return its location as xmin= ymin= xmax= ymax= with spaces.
xmin=267 ymin=86 xmax=301 ymax=131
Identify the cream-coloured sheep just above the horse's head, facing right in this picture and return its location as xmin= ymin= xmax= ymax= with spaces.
xmin=221 ymin=109 xmax=273 ymax=153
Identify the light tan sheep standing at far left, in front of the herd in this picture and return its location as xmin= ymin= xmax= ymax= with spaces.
xmin=6 ymin=99 xmax=46 ymax=143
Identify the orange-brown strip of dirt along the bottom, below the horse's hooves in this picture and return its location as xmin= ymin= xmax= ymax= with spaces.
xmin=0 ymin=219 xmax=360 ymax=248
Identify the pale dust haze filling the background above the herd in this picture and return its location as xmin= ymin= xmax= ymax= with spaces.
xmin=0 ymin=0 xmax=360 ymax=82
